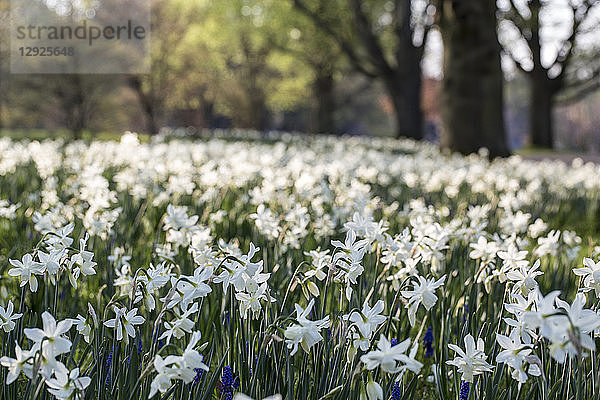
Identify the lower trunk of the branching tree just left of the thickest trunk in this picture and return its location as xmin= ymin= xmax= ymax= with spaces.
xmin=384 ymin=72 xmax=424 ymax=140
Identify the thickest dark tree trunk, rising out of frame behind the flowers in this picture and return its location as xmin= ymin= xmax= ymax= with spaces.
xmin=439 ymin=0 xmax=509 ymax=157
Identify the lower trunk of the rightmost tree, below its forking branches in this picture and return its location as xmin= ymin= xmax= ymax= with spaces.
xmin=529 ymin=73 xmax=554 ymax=149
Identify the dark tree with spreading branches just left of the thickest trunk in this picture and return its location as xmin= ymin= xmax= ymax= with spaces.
xmin=293 ymin=0 xmax=433 ymax=139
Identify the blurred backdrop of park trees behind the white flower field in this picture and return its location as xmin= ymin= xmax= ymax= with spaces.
xmin=0 ymin=0 xmax=600 ymax=155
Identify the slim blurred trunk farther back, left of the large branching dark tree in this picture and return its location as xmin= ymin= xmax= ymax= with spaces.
xmin=311 ymin=66 xmax=335 ymax=133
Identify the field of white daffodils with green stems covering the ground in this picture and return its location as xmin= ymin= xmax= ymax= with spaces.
xmin=0 ymin=132 xmax=600 ymax=400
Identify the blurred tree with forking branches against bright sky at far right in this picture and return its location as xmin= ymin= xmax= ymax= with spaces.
xmin=500 ymin=0 xmax=600 ymax=148
